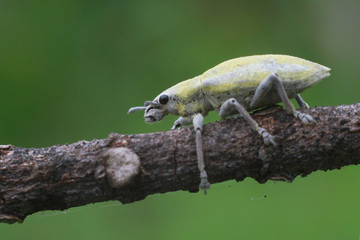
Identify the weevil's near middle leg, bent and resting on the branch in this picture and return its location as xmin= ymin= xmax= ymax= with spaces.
xmin=219 ymin=98 xmax=276 ymax=146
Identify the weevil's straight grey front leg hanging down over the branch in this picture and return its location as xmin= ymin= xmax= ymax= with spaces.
xmin=193 ymin=113 xmax=210 ymax=194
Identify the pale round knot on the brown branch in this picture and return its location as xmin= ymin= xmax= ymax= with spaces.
xmin=104 ymin=147 xmax=140 ymax=188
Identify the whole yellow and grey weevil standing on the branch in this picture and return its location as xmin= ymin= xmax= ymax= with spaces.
xmin=128 ymin=54 xmax=330 ymax=194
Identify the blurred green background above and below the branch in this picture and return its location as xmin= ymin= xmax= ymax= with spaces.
xmin=0 ymin=0 xmax=360 ymax=239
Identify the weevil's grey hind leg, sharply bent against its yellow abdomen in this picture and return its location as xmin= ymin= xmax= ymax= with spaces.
xmin=250 ymin=73 xmax=316 ymax=124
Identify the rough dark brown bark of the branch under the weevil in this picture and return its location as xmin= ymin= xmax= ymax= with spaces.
xmin=0 ymin=103 xmax=360 ymax=223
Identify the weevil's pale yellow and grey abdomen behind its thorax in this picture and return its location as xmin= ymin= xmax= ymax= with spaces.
xmin=200 ymin=55 xmax=330 ymax=109
